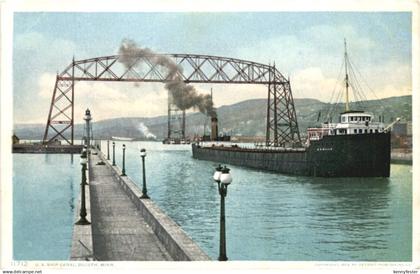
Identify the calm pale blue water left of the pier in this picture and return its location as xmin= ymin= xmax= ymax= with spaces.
xmin=13 ymin=154 xmax=81 ymax=260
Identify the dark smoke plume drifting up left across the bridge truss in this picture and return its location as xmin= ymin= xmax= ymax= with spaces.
xmin=119 ymin=39 xmax=216 ymax=117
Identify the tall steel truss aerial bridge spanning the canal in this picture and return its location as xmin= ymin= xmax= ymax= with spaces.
xmin=43 ymin=54 xmax=301 ymax=146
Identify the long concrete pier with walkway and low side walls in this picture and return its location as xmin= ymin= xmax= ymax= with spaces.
xmin=70 ymin=150 xmax=210 ymax=261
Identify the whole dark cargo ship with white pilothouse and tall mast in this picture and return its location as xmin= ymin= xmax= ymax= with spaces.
xmin=192 ymin=40 xmax=399 ymax=177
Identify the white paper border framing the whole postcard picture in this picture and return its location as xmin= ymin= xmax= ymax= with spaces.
xmin=0 ymin=0 xmax=420 ymax=273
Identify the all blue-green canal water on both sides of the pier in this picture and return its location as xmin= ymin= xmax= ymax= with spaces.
xmin=14 ymin=142 xmax=412 ymax=261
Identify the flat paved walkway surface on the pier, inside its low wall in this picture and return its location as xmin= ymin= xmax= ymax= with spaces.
xmin=89 ymin=152 xmax=172 ymax=261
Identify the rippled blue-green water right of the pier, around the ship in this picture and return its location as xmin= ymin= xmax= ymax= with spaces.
xmin=106 ymin=142 xmax=412 ymax=261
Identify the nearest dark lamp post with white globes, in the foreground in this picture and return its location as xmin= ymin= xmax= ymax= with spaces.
xmin=213 ymin=165 xmax=232 ymax=261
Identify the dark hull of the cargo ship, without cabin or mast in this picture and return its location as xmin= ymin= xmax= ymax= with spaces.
xmin=192 ymin=132 xmax=391 ymax=177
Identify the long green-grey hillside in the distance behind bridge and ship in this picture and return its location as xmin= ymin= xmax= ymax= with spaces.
xmin=14 ymin=96 xmax=412 ymax=140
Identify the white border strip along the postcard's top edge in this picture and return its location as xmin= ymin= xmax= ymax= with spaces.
xmin=3 ymin=0 xmax=418 ymax=12
